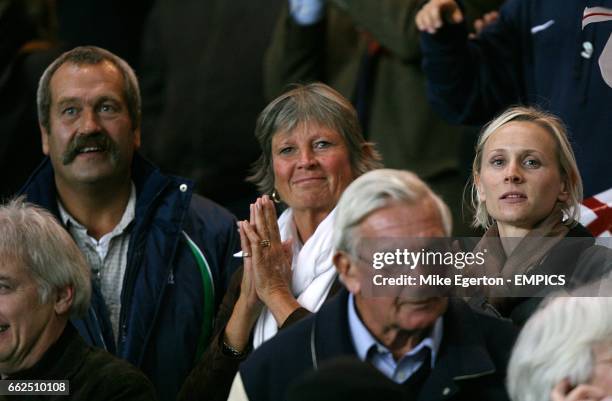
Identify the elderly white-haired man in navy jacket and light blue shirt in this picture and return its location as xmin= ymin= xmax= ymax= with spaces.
xmin=225 ymin=169 xmax=515 ymax=401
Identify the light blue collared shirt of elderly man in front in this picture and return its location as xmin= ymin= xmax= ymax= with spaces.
xmin=348 ymin=294 xmax=443 ymax=383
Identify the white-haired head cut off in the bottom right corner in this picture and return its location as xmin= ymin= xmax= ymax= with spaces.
xmin=507 ymin=297 xmax=612 ymax=401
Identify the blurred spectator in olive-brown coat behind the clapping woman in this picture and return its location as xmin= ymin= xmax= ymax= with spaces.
xmin=264 ymin=0 xmax=502 ymax=235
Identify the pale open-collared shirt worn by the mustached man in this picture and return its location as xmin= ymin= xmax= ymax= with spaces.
xmin=57 ymin=183 xmax=136 ymax=341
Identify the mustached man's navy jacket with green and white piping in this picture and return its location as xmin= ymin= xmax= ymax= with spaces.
xmin=17 ymin=155 xmax=239 ymax=400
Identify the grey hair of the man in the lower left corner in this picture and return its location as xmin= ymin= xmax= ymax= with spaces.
xmin=0 ymin=197 xmax=91 ymax=317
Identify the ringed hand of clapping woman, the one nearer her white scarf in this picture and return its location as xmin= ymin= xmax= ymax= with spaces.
xmin=243 ymin=195 xmax=300 ymax=325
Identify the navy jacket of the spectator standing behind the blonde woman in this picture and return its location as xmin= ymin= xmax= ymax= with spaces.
xmin=421 ymin=0 xmax=612 ymax=197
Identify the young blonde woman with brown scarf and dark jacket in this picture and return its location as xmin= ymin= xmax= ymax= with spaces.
xmin=471 ymin=107 xmax=609 ymax=325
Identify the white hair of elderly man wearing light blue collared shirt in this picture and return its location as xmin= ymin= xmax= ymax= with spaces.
xmin=334 ymin=169 xmax=453 ymax=254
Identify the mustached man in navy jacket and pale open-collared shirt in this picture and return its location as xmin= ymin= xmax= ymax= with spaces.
xmin=15 ymin=47 xmax=238 ymax=400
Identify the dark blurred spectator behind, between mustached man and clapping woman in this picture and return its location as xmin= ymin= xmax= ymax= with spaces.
xmin=141 ymin=0 xmax=281 ymax=217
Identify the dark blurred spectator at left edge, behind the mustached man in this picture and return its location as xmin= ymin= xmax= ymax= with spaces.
xmin=0 ymin=0 xmax=59 ymax=199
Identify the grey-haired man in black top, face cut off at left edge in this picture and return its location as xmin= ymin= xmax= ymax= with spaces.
xmin=0 ymin=199 xmax=156 ymax=401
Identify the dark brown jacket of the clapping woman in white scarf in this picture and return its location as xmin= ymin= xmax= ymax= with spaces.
xmin=178 ymin=268 xmax=341 ymax=401
